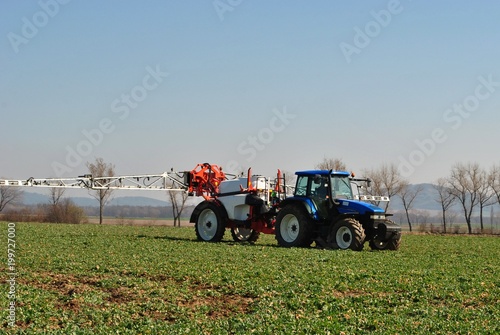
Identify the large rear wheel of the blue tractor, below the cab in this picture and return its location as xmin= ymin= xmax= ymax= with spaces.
xmin=275 ymin=205 xmax=311 ymax=248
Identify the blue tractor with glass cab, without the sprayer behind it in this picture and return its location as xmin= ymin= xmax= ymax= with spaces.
xmin=275 ymin=170 xmax=401 ymax=251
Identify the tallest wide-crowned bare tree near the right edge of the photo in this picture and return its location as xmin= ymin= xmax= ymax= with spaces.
xmin=448 ymin=163 xmax=481 ymax=234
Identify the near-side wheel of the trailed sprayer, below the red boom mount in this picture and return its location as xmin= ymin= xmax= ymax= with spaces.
xmin=195 ymin=201 xmax=226 ymax=242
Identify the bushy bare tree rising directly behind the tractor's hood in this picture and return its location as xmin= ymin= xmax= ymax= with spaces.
xmin=363 ymin=164 xmax=406 ymax=211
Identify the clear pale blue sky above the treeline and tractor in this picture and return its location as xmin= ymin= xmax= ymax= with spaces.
xmin=0 ymin=0 xmax=500 ymax=183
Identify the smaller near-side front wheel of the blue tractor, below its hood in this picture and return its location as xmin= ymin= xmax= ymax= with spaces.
xmin=328 ymin=218 xmax=366 ymax=251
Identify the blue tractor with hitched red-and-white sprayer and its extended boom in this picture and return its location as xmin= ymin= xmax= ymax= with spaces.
xmin=0 ymin=163 xmax=401 ymax=251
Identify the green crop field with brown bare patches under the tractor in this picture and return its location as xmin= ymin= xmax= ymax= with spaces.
xmin=0 ymin=223 xmax=500 ymax=335
